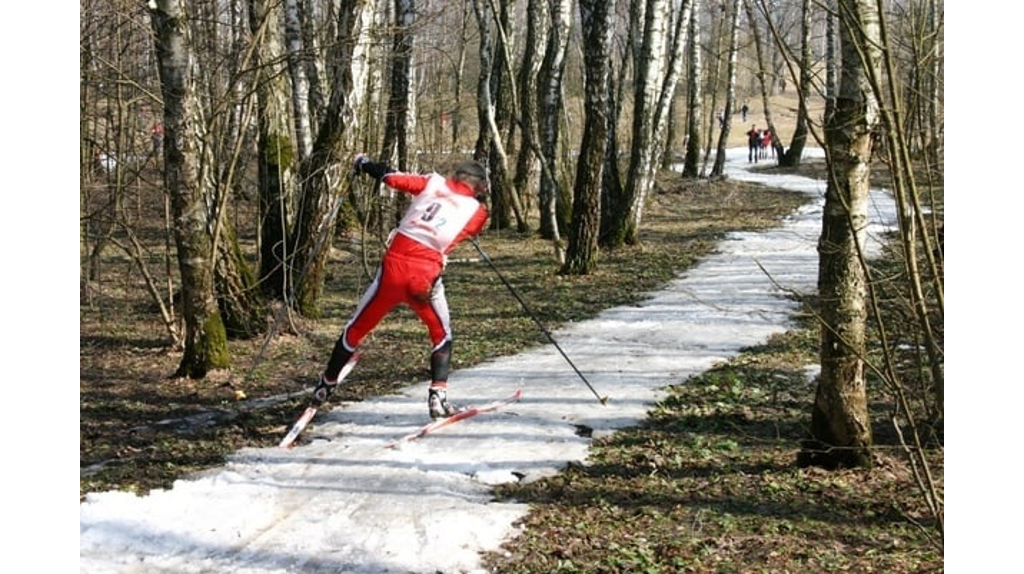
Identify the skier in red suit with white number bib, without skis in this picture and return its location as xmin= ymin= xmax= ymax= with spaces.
xmin=313 ymin=156 xmax=488 ymax=418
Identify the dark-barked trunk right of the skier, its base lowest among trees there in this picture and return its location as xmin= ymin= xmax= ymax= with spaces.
xmin=561 ymin=0 xmax=615 ymax=275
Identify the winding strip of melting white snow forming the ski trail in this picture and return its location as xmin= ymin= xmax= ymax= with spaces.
xmin=79 ymin=149 xmax=895 ymax=574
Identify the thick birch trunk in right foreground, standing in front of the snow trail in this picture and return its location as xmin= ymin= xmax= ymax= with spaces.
xmin=799 ymin=0 xmax=881 ymax=469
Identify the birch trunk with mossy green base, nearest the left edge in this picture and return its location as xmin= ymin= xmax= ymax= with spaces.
xmin=150 ymin=0 xmax=229 ymax=379
